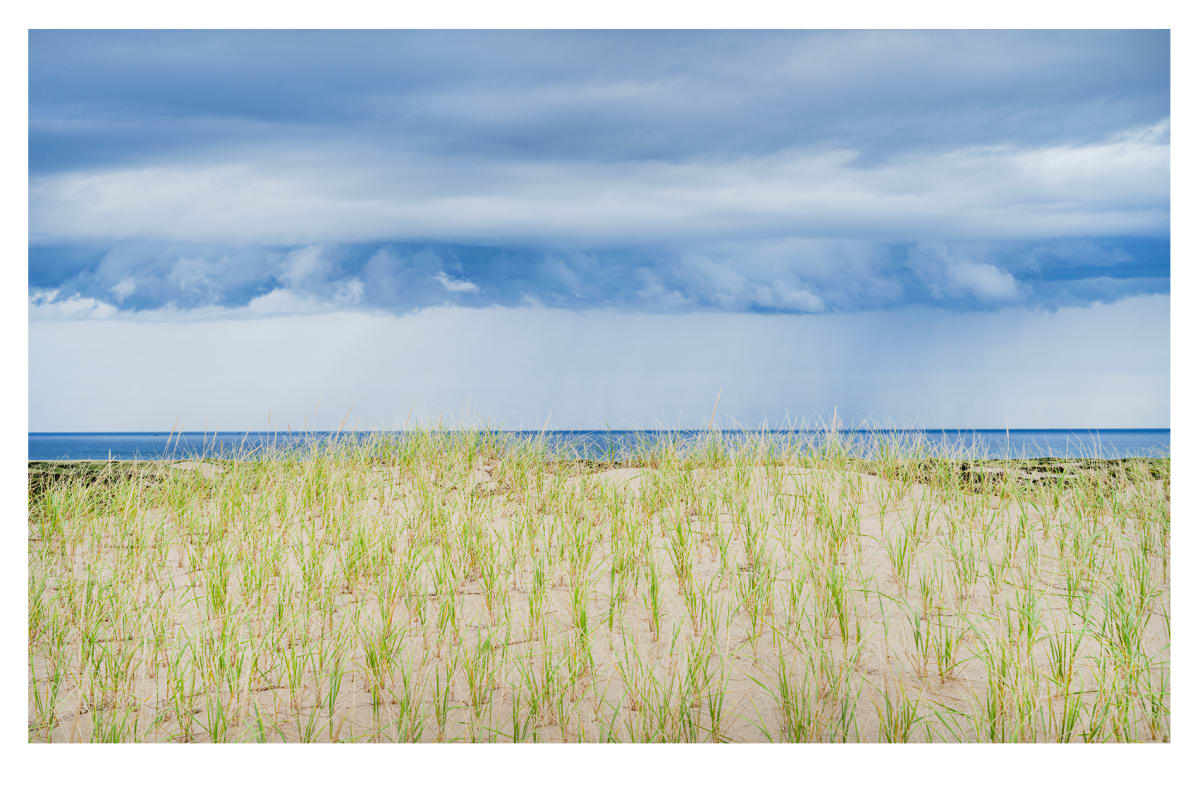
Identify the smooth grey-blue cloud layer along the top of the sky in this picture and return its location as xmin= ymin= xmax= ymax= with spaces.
xmin=30 ymin=31 xmax=1170 ymax=173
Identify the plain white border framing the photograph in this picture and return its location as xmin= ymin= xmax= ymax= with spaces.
xmin=7 ymin=0 xmax=1200 ymax=797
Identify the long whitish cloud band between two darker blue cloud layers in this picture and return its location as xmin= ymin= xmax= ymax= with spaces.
xmin=30 ymin=120 xmax=1170 ymax=246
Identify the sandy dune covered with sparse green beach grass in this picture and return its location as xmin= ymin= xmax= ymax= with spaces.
xmin=28 ymin=430 xmax=1170 ymax=742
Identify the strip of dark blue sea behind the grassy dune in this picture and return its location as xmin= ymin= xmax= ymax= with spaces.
xmin=29 ymin=429 xmax=1171 ymax=460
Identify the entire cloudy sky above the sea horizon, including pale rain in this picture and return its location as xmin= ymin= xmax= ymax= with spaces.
xmin=29 ymin=31 xmax=1170 ymax=431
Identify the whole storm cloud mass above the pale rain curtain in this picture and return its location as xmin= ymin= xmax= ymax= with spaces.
xmin=30 ymin=31 xmax=1170 ymax=313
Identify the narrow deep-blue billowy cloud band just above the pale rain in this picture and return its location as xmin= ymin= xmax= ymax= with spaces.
xmin=30 ymin=239 xmax=1170 ymax=312
